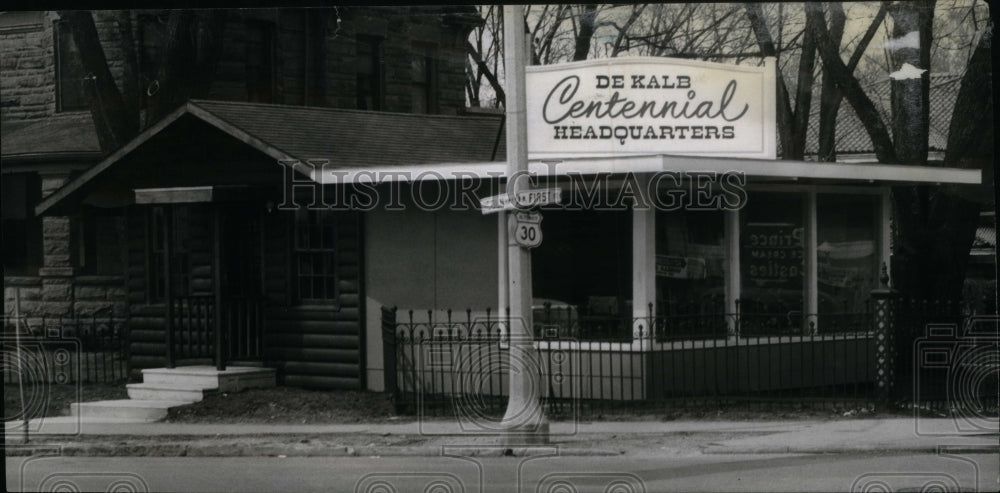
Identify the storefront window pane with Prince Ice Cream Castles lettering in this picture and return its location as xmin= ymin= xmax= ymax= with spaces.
xmin=739 ymin=193 xmax=806 ymax=335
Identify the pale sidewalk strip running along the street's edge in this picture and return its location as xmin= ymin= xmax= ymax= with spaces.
xmin=6 ymin=417 xmax=1000 ymax=456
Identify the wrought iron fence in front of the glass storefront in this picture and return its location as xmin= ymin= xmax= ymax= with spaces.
xmin=382 ymin=299 xmax=995 ymax=417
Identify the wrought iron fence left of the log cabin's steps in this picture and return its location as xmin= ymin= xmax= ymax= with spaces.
xmin=3 ymin=313 xmax=128 ymax=385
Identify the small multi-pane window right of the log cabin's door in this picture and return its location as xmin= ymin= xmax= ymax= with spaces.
xmin=292 ymin=209 xmax=337 ymax=305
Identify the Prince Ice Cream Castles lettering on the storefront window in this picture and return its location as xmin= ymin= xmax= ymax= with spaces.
xmin=740 ymin=223 xmax=805 ymax=289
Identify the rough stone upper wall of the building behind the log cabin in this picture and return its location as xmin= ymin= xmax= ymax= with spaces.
xmin=0 ymin=7 xmax=467 ymax=120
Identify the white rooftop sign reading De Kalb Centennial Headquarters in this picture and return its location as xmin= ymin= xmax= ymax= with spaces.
xmin=525 ymin=57 xmax=777 ymax=159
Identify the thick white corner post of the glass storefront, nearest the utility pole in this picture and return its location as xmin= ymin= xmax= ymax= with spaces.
xmin=632 ymin=175 xmax=656 ymax=345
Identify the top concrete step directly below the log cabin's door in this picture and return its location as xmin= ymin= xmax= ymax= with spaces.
xmin=142 ymin=365 xmax=276 ymax=392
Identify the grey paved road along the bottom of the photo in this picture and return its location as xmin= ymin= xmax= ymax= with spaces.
xmin=6 ymin=454 xmax=1000 ymax=493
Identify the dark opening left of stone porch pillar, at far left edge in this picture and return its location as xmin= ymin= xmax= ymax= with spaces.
xmin=2 ymin=173 xmax=42 ymax=276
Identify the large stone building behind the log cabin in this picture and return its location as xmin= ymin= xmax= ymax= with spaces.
xmin=0 ymin=7 xmax=479 ymax=317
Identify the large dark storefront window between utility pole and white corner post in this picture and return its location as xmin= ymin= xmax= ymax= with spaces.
xmin=531 ymin=206 xmax=632 ymax=341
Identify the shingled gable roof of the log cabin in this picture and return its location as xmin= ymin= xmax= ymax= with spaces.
xmin=35 ymin=100 xmax=504 ymax=214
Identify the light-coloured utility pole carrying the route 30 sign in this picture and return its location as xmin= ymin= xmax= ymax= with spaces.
xmin=500 ymin=5 xmax=549 ymax=445
